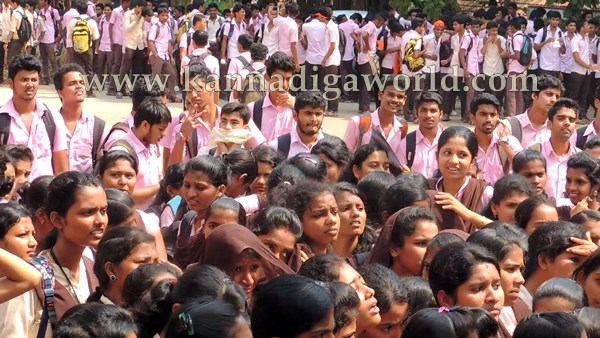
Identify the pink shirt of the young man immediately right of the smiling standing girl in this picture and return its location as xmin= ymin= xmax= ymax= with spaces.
xmin=476 ymin=133 xmax=523 ymax=185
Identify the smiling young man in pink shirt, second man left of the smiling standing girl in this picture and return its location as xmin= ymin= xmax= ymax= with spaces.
xmin=344 ymin=77 xmax=406 ymax=151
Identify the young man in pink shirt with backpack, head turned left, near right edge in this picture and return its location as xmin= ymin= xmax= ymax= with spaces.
xmin=506 ymin=75 xmax=565 ymax=148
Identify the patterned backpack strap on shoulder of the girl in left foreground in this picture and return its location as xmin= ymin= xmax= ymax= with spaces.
xmin=29 ymin=256 xmax=58 ymax=338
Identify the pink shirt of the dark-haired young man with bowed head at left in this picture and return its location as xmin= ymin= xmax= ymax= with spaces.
xmin=112 ymin=130 xmax=161 ymax=210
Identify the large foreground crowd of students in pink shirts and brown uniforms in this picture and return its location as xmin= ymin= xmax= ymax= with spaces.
xmin=0 ymin=0 xmax=600 ymax=338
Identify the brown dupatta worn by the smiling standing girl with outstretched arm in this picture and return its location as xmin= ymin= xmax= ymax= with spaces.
xmin=427 ymin=178 xmax=489 ymax=234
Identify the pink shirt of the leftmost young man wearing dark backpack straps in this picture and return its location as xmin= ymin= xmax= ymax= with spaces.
xmin=0 ymin=98 xmax=67 ymax=181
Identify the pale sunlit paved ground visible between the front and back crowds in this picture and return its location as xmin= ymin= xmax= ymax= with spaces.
xmin=0 ymin=85 xmax=462 ymax=137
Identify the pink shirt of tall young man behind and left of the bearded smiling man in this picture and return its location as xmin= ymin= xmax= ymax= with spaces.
xmin=248 ymin=93 xmax=296 ymax=144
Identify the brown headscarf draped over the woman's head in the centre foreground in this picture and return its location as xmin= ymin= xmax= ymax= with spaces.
xmin=198 ymin=224 xmax=294 ymax=280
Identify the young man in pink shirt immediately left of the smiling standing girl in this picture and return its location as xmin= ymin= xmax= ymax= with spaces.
xmin=396 ymin=92 xmax=443 ymax=178
